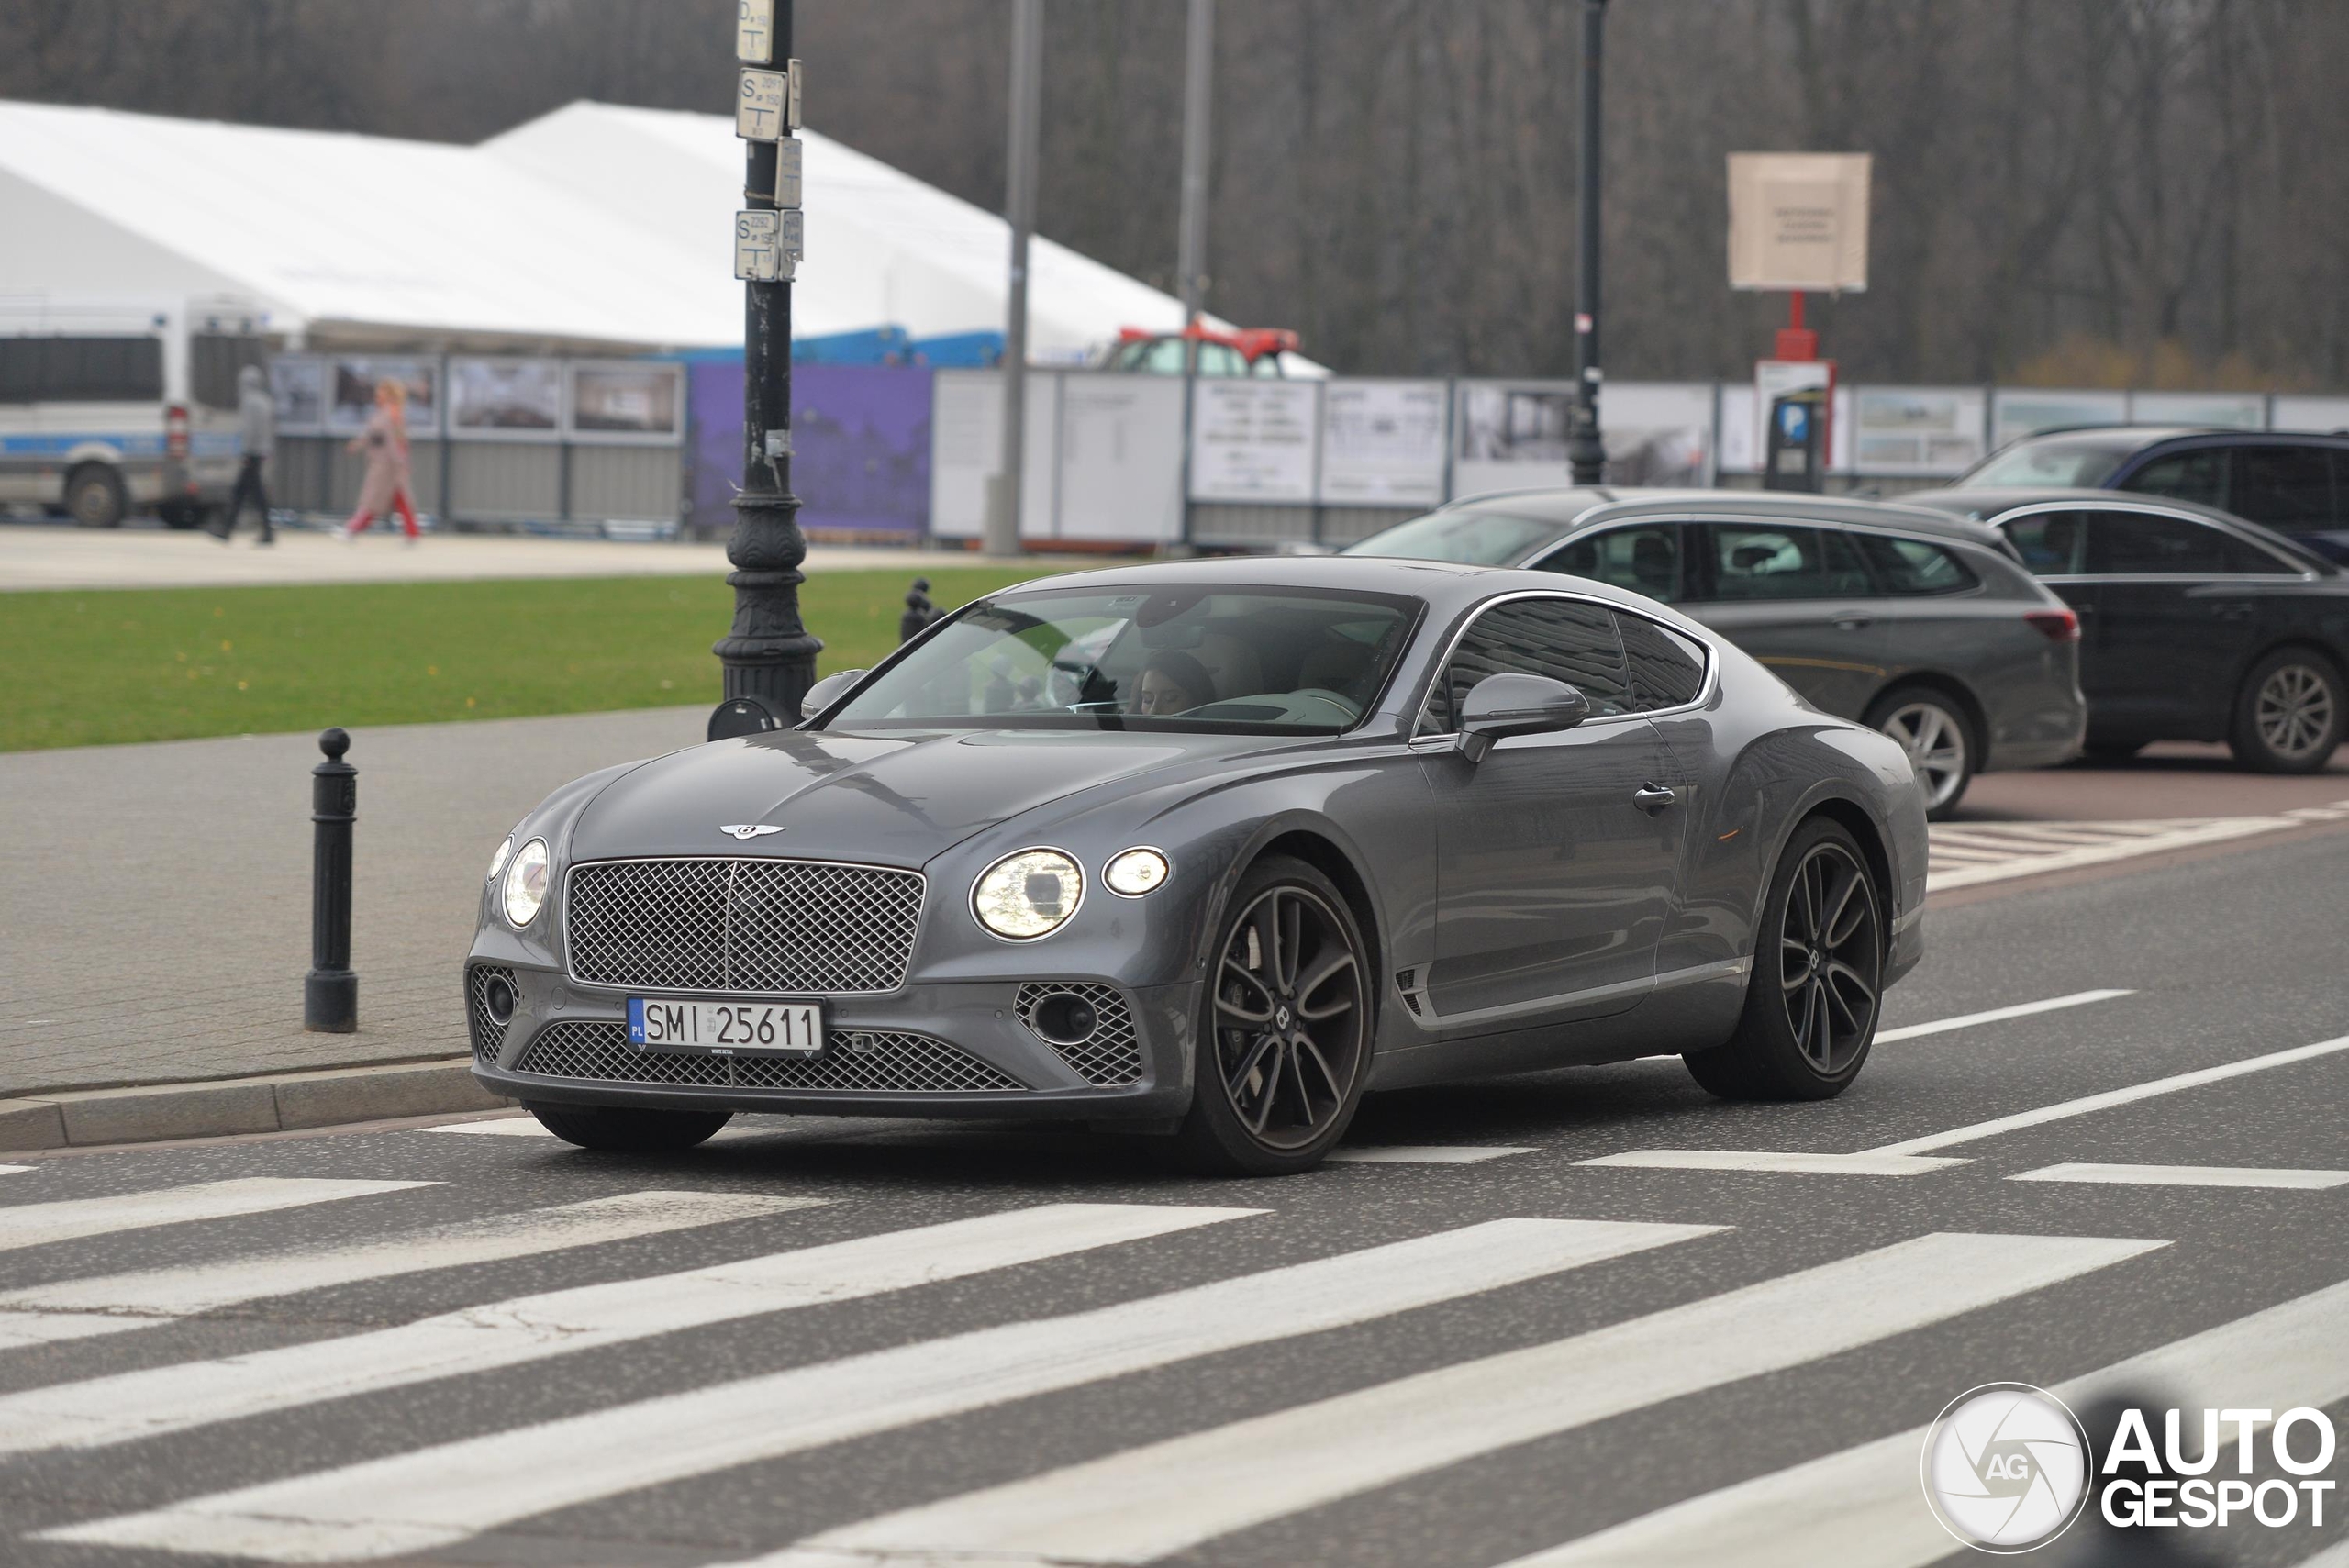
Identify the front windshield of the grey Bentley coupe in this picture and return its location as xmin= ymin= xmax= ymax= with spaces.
xmin=829 ymin=584 xmax=1419 ymax=735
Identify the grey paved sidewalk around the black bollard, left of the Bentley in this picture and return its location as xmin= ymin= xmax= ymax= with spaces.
xmin=0 ymin=704 xmax=709 ymax=1098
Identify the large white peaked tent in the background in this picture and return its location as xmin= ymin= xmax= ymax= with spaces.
xmin=0 ymin=101 xmax=1230 ymax=359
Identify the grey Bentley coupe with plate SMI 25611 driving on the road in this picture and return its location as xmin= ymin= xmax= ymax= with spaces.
xmin=465 ymin=559 xmax=1926 ymax=1173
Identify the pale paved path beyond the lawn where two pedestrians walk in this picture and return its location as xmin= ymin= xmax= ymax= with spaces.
xmin=0 ymin=521 xmax=1069 ymax=592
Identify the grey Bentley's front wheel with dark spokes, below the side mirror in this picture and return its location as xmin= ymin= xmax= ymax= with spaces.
xmin=1174 ymin=854 xmax=1376 ymax=1176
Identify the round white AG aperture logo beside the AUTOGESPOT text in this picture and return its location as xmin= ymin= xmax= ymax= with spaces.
xmin=1921 ymin=1383 xmax=2088 ymax=1554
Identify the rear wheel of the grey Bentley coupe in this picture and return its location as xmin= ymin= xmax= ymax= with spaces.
xmin=1682 ymin=817 xmax=1887 ymax=1101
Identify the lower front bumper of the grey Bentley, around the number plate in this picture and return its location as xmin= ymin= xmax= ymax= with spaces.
xmin=465 ymin=958 xmax=1198 ymax=1119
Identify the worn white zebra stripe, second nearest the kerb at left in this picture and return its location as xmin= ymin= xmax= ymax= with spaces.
xmin=0 ymin=1193 xmax=825 ymax=1350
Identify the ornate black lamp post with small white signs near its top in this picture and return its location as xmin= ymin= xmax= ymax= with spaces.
xmin=709 ymin=0 xmax=822 ymax=740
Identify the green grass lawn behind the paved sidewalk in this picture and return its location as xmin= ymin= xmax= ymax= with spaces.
xmin=0 ymin=568 xmax=1041 ymax=751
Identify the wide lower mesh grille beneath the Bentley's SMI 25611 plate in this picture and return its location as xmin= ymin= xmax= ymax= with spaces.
xmin=515 ymin=1018 xmax=1027 ymax=1094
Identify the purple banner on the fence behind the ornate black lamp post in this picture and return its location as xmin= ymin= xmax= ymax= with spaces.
xmin=686 ymin=359 xmax=930 ymax=542
